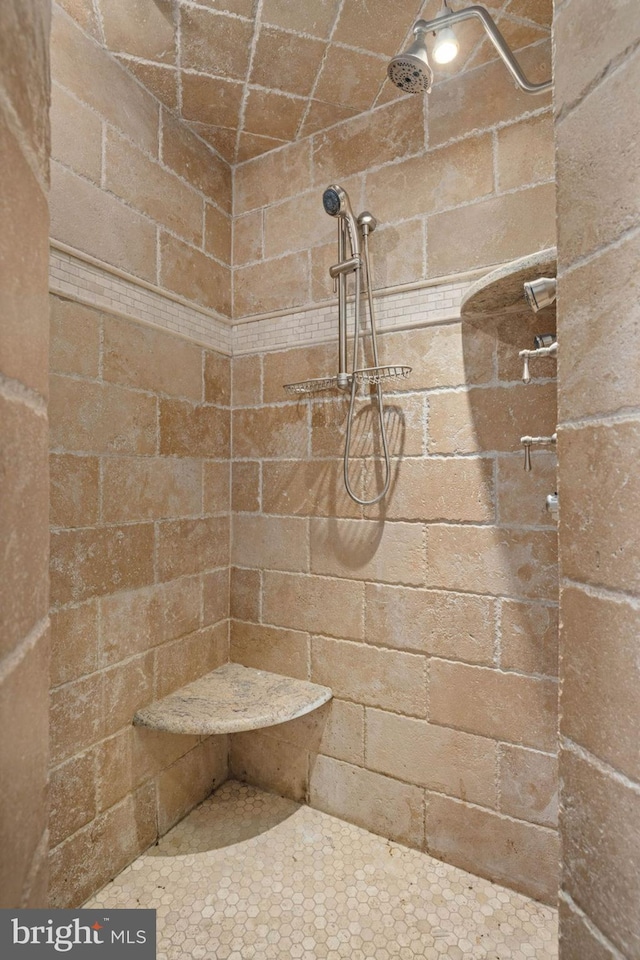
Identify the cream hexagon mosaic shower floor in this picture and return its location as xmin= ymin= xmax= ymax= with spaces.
xmin=86 ymin=781 xmax=558 ymax=960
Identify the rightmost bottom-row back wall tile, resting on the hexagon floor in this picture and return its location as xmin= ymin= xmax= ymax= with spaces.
xmin=427 ymin=796 xmax=559 ymax=904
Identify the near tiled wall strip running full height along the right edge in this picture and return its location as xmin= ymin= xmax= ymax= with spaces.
xmin=555 ymin=0 xmax=640 ymax=960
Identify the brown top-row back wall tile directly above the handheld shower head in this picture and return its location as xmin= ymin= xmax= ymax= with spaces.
xmin=313 ymin=97 xmax=424 ymax=185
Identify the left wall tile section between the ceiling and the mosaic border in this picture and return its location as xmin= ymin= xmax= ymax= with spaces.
xmin=51 ymin=3 xmax=231 ymax=317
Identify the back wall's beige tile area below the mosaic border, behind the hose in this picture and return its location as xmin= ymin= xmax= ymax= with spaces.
xmin=231 ymin=313 xmax=559 ymax=901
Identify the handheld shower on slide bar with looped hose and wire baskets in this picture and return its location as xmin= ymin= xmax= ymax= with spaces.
xmin=284 ymin=184 xmax=411 ymax=506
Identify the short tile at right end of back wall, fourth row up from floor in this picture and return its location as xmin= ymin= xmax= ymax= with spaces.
xmin=500 ymin=600 xmax=558 ymax=677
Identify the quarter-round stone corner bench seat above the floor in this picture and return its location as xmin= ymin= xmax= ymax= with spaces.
xmin=133 ymin=663 xmax=333 ymax=736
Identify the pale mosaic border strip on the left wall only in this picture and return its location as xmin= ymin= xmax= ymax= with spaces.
xmin=49 ymin=241 xmax=233 ymax=356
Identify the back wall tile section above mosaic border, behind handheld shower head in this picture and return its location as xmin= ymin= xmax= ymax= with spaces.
xmin=233 ymin=35 xmax=555 ymax=322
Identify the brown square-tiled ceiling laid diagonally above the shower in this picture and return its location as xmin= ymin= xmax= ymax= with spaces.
xmin=85 ymin=0 xmax=552 ymax=163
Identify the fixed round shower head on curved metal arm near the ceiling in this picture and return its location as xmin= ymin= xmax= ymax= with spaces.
xmin=387 ymin=0 xmax=553 ymax=93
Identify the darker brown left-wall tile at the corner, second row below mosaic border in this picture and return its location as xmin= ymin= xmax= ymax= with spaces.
xmin=160 ymin=400 xmax=230 ymax=459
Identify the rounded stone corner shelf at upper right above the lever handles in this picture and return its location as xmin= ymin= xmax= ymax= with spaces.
xmin=460 ymin=247 xmax=557 ymax=320
